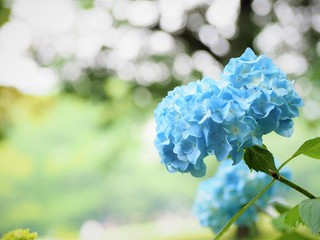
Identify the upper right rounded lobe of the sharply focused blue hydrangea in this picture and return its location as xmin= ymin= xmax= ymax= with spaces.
xmin=221 ymin=48 xmax=303 ymax=138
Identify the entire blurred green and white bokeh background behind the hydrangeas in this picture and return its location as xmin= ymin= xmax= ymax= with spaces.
xmin=0 ymin=0 xmax=320 ymax=240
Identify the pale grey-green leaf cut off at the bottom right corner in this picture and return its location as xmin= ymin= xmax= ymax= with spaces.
xmin=299 ymin=199 xmax=320 ymax=235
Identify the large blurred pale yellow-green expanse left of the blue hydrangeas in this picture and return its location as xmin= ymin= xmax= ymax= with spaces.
xmin=0 ymin=84 xmax=210 ymax=236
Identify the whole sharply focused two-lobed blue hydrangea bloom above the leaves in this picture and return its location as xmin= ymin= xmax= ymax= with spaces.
xmin=154 ymin=48 xmax=303 ymax=177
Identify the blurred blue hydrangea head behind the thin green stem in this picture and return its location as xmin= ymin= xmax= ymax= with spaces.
xmin=193 ymin=160 xmax=290 ymax=232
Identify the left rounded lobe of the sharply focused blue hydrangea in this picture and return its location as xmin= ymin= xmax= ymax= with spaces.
xmin=154 ymin=78 xmax=226 ymax=177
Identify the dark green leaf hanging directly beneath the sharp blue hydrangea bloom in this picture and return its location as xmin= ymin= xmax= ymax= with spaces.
xmin=244 ymin=146 xmax=279 ymax=178
